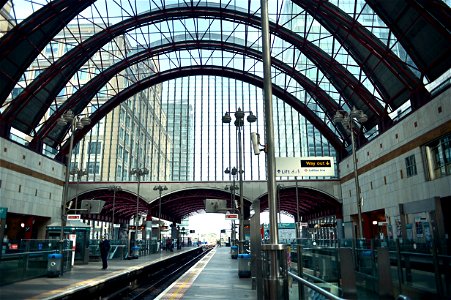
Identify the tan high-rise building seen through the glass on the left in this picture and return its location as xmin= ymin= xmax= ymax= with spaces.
xmin=11 ymin=24 xmax=172 ymax=181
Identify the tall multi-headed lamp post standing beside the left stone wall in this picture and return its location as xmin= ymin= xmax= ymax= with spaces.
xmin=57 ymin=110 xmax=91 ymax=241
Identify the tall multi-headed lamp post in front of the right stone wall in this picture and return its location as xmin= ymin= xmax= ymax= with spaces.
xmin=334 ymin=107 xmax=368 ymax=239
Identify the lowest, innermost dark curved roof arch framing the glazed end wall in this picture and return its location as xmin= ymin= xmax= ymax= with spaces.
xmin=55 ymin=66 xmax=346 ymax=161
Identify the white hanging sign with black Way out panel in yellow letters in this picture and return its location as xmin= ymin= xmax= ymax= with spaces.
xmin=276 ymin=156 xmax=335 ymax=177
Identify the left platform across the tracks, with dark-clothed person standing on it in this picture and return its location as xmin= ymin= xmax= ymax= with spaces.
xmin=0 ymin=247 xmax=192 ymax=300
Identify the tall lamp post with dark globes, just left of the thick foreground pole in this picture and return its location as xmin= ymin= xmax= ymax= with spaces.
xmin=222 ymin=108 xmax=257 ymax=253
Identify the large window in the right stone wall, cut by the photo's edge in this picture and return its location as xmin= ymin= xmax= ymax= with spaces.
xmin=425 ymin=134 xmax=451 ymax=180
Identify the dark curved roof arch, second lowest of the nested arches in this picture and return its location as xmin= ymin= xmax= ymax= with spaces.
xmin=33 ymin=40 xmax=349 ymax=148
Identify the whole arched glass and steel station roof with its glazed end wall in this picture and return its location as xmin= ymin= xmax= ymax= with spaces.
xmin=0 ymin=0 xmax=451 ymax=181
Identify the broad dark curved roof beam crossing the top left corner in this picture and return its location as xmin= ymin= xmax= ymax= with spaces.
xmin=0 ymin=0 xmax=95 ymax=105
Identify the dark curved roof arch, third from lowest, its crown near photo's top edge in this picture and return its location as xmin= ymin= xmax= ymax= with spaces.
xmin=4 ymin=4 xmax=386 ymax=138
